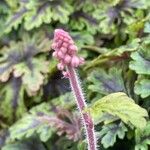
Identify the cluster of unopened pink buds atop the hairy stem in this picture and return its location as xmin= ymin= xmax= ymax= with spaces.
xmin=52 ymin=29 xmax=84 ymax=71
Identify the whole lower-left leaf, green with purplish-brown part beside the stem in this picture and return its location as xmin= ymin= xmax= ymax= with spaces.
xmin=10 ymin=103 xmax=81 ymax=142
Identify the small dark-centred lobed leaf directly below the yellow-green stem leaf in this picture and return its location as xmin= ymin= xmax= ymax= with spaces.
xmin=99 ymin=122 xmax=128 ymax=148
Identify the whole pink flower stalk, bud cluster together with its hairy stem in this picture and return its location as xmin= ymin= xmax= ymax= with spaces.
xmin=52 ymin=29 xmax=97 ymax=150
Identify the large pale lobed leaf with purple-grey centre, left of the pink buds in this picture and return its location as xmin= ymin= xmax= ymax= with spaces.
xmin=0 ymin=32 xmax=50 ymax=95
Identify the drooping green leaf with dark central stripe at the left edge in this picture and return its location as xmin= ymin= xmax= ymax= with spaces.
xmin=0 ymin=78 xmax=26 ymax=122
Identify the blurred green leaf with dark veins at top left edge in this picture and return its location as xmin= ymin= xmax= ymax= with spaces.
xmin=6 ymin=0 xmax=72 ymax=32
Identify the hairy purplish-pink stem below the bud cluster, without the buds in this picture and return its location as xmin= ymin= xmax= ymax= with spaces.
xmin=67 ymin=66 xmax=97 ymax=150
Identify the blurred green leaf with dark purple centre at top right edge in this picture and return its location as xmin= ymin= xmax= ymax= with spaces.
xmin=93 ymin=0 xmax=148 ymax=35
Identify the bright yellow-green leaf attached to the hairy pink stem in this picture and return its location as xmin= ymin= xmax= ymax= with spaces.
xmin=87 ymin=92 xmax=148 ymax=128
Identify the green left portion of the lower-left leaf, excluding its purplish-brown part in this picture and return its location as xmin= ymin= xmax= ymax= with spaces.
xmin=9 ymin=103 xmax=55 ymax=142
